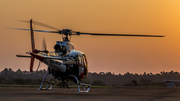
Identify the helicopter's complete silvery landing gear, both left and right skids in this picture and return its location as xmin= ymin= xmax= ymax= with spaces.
xmin=38 ymin=73 xmax=91 ymax=93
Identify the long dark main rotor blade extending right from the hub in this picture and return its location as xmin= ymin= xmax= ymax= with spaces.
xmin=76 ymin=32 xmax=164 ymax=37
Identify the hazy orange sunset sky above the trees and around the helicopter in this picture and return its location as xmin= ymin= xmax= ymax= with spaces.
xmin=0 ymin=0 xmax=180 ymax=74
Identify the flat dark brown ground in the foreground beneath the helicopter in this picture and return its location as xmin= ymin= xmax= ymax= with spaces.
xmin=0 ymin=87 xmax=180 ymax=101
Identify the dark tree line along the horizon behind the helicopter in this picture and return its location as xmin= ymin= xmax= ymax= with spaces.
xmin=0 ymin=68 xmax=180 ymax=86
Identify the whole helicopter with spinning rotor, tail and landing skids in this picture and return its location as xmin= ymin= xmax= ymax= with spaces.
xmin=11 ymin=19 xmax=164 ymax=93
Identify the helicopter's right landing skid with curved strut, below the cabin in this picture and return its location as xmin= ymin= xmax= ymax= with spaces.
xmin=69 ymin=75 xmax=91 ymax=93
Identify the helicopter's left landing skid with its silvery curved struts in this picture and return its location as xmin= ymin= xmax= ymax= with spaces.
xmin=38 ymin=73 xmax=55 ymax=90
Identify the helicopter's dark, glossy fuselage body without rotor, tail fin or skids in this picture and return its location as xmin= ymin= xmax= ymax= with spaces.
xmin=30 ymin=46 xmax=88 ymax=80
